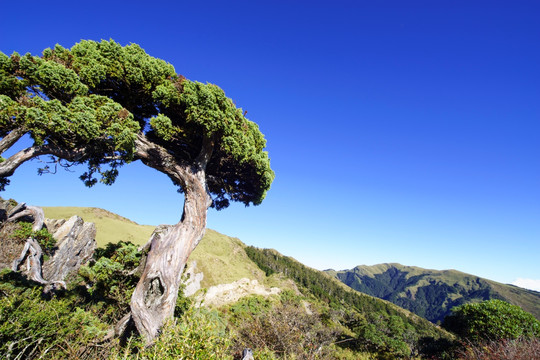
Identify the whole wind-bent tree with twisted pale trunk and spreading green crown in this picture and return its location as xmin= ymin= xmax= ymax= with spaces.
xmin=0 ymin=40 xmax=274 ymax=342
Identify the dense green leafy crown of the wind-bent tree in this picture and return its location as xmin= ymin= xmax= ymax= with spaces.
xmin=0 ymin=40 xmax=274 ymax=209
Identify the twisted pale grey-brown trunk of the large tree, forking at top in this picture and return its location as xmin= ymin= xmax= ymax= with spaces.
xmin=127 ymin=136 xmax=213 ymax=343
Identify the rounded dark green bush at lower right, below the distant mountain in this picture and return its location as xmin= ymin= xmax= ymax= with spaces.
xmin=443 ymin=300 xmax=540 ymax=342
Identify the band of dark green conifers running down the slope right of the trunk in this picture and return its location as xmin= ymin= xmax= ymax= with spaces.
xmin=245 ymin=247 xmax=447 ymax=358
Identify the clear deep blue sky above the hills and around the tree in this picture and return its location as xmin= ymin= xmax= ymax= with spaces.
xmin=0 ymin=0 xmax=540 ymax=283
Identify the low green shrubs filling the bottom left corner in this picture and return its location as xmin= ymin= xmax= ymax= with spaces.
xmin=0 ymin=271 xmax=107 ymax=359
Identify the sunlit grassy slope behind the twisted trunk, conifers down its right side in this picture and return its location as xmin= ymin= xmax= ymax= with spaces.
xmin=35 ymin=208 xmax=452 ymax=358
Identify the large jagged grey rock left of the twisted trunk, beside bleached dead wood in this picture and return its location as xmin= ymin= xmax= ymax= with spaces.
xmin=43 ymin=215 xmax=96 ymax=281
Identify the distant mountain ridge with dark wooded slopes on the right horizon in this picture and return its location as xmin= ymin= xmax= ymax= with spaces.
xmin=325 ymin=263 xmax=540 ymax=323
